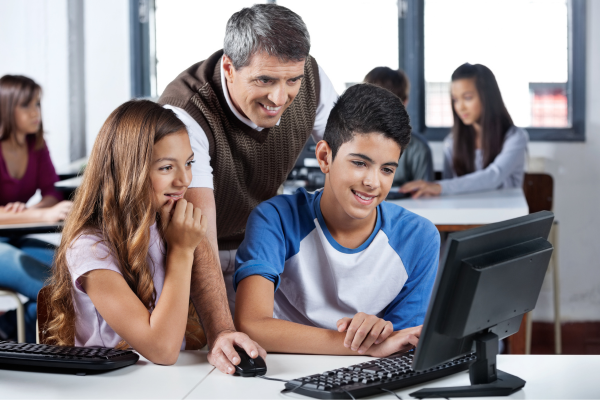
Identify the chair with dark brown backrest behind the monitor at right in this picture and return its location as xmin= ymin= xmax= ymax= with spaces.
xmin=511 ymin=174 xmax=562 ymax=354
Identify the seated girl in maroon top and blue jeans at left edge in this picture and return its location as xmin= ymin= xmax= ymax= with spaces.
xmin=0 ymin=75 xmax=71 ymax=342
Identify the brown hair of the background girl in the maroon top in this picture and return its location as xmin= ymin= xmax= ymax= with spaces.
xmin=0 ymin=75 xmax=44 ymax=150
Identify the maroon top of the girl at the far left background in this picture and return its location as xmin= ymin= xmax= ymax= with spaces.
xmin=0 ymin=135 xmax=63 ymax=206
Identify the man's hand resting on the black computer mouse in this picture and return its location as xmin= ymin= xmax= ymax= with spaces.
xmin=209 ymin=330 xmax=267 ymax=375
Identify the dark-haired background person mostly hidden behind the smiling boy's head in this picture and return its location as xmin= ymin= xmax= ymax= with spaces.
xmin=364 ymin=67 xmax=433 ymax=186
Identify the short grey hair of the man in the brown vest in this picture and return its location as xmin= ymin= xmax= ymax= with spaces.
xmin=223 ymin=4 xmax=310 ymax=69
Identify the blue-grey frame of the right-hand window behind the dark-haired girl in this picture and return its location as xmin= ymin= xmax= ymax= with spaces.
xmin=398 ymin=0 xmax=586 ymax=142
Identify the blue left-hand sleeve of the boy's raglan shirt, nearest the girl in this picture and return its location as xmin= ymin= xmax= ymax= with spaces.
xmin=233 ymin=202 xmax=286 ymax=290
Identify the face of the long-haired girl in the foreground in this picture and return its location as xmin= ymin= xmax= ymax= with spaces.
xmin=150 ymin=129 xmax=194 ymax=210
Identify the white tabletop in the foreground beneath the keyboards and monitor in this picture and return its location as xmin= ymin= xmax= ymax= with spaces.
xmin=0 ymin=351 xmax=600 ymax=399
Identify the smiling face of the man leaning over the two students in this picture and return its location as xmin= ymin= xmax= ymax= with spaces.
xmin=223 ymin=52 xmax=304 ymax=128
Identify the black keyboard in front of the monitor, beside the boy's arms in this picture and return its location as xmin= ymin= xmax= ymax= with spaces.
xmin=285 ymin=350 xmax=476 ymax=399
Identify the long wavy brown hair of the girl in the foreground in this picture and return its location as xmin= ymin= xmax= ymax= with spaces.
xmin=46 ymin=100 xmax=206 ymax=347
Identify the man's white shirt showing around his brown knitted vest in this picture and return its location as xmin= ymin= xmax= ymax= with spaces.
xmin=164 ymin=57 xmax=338 ymax=189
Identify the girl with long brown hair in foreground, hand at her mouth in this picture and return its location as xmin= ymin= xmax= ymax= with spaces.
xmin=47 ymin=100 xmax=206 ymax=364
